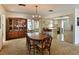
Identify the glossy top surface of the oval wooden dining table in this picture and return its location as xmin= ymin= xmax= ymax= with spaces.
xmin=27 ymin=32 xmax=48 ymax=40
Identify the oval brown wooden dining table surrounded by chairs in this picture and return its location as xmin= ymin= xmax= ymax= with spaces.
xmin=27 ymin=32 xmax=48 ymax=53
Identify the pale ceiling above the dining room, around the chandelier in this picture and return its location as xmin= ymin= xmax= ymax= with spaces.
xmin=3 ymin=4 xmax=79 ymax=16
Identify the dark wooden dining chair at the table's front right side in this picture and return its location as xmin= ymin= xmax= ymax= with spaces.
xmin=37 ymin=36 xmax=52 ymax=55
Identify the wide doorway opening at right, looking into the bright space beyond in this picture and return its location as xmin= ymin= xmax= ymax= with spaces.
xmin=53 ymin=16 xmax=74 ymax=43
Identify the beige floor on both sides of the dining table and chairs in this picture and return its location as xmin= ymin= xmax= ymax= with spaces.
xmin=0 ymin=38 xmax=79 ymax=55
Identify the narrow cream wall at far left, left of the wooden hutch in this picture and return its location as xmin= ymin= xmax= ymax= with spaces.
xmin=0 ymin=5 xmax=5 ymax=50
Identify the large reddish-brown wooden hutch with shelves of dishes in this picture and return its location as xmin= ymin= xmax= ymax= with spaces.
xmin=6 ymin=17 xmax=27 ymax=40
